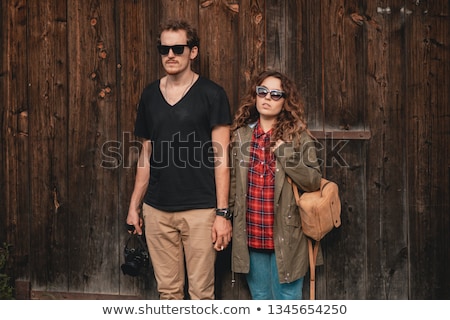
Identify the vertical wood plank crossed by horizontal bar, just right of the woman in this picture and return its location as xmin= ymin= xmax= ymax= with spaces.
xmin=313 ymin=1 xmax=366 ymax=299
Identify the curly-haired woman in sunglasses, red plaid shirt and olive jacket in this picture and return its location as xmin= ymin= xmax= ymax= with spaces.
xmin=230 ymin=71 xmax=322 ymax=300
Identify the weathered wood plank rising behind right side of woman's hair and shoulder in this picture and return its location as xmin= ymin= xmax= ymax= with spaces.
xmin=294 ymin=1 xmax=326 ymax=299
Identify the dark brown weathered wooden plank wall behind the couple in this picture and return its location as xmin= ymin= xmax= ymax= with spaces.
xmin=0 ymin=0 xmax=450 ymax=299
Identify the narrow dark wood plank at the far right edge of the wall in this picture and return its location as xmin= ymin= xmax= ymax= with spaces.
xmin=428 ymin=1 xmax=450 ymax=299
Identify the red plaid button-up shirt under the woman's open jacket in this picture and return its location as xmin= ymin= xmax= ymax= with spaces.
xmin=247 ymin=122 xmax=276 ymax=249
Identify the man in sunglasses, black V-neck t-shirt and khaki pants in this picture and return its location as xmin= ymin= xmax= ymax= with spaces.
xmin=127 ymin=21 xmax=232 ymax=299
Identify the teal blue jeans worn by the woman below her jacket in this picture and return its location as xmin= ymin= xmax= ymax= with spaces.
xmin=246 ymin=250 xmax=303 ymax=300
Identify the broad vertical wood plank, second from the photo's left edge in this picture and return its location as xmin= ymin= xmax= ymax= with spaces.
xmin=27 ymin=1 xmax=69 ymax=290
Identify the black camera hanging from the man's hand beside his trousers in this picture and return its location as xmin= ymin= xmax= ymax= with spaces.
xmin=120 ymin=234 xmax=150 ymax=277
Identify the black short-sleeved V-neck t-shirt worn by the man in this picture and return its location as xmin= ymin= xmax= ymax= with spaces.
xmin=134 ymin=77 xmax=231 ymax=211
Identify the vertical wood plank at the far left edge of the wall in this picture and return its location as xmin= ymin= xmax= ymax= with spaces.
xmin=1 ymin=1 xmax=32 ymax=279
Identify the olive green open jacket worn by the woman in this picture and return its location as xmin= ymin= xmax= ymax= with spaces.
xmin=229 ymin=125 xmax=322 ymax=283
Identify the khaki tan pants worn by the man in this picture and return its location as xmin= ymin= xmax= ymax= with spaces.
xmin=143 ymin=204 xmax=216 ymax=300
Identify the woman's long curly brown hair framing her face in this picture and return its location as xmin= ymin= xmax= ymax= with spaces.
xmin=231 ymin=70 xmax=309 ymax=143
